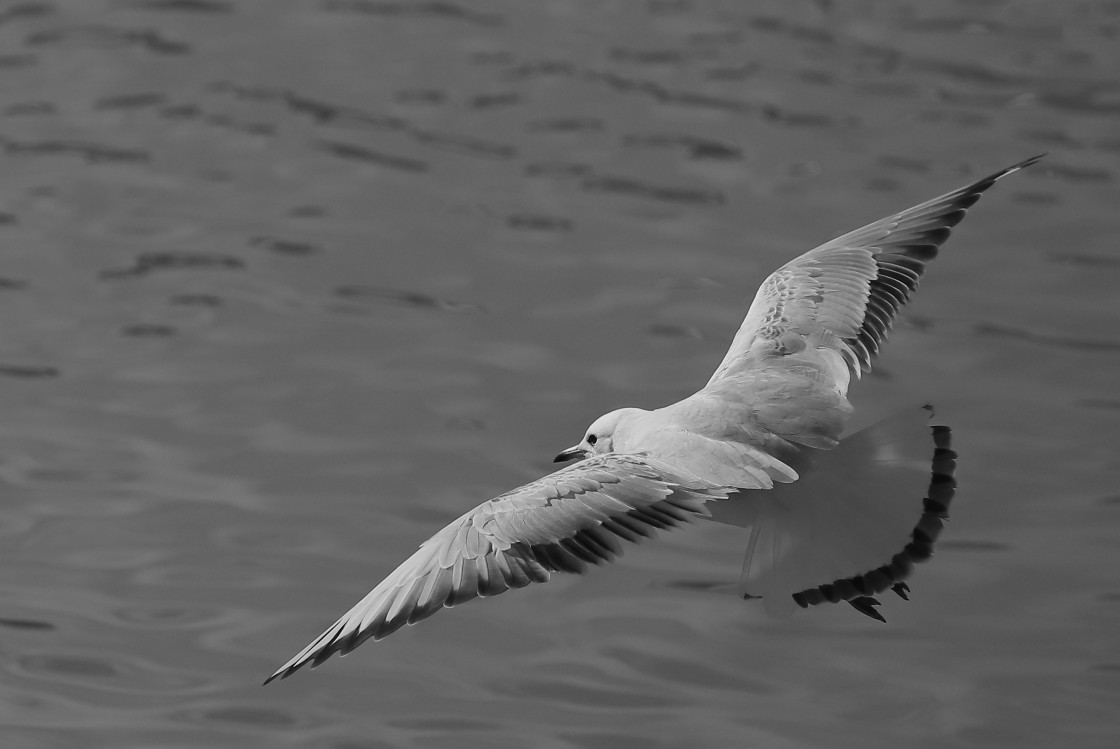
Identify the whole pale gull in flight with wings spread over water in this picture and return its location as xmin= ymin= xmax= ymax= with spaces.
xmin=265 ymin=157 xmax=1042 ymax=684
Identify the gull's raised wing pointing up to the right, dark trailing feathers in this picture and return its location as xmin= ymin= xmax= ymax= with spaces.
xmin=708 ymin=156 xmax=1042 ymax=390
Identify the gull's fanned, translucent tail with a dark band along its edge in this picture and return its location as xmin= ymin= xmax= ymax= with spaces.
xmin=712 ymin=406 xmax=956 ymax=620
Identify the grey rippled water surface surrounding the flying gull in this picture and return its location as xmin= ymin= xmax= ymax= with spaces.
xmin=0 ymin=0 xmax=1120 ymax=749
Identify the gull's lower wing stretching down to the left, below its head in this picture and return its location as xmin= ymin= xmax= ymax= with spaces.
xmin=265 ymin=453 xmax=727 ymax=684
